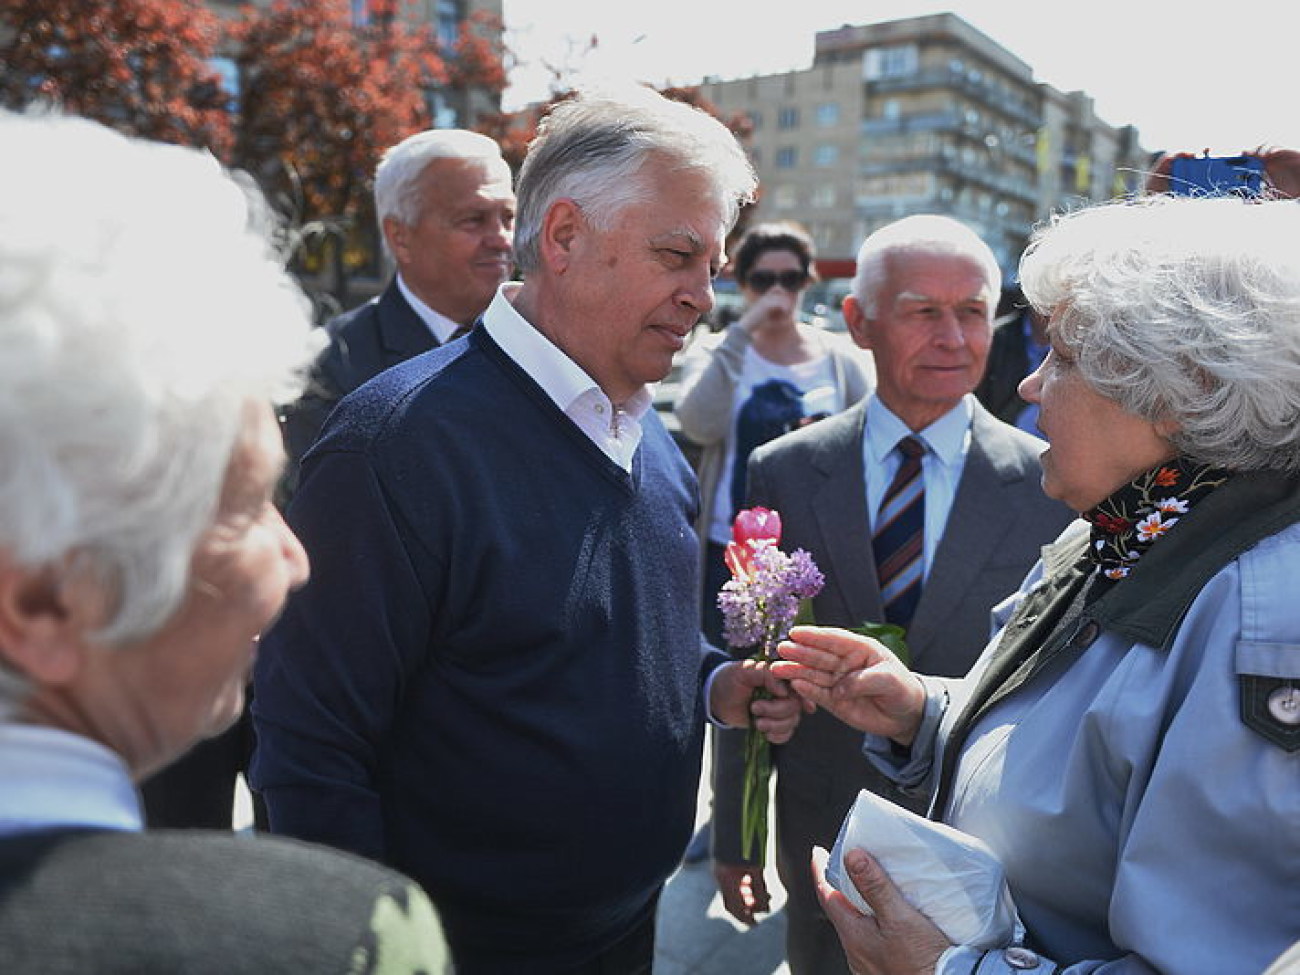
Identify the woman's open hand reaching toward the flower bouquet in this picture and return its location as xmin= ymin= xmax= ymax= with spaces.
xmin=772 ymin=627 xmax=926 ymax=745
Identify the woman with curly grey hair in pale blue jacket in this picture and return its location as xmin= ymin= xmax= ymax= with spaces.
xmin=781 ymin=198 xmax=1300 ymax=975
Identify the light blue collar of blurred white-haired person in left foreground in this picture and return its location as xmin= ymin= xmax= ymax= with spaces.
xmin=0 ymin=724 xmax=144 ymax=836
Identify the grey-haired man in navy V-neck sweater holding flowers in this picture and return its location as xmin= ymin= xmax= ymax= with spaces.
xmin=252 ymin=90 xmax=800 ymax=975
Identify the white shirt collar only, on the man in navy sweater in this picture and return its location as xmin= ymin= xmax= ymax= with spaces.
xmin=484 ymin=281 xmax=654 ymax=420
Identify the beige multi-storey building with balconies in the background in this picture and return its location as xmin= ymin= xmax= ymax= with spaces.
xmin=701 ymin=13 xmax=1148 ymax=278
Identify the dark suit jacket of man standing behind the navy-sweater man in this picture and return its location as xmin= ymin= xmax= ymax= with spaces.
xmin=281 ymin=278 xmax=438 ymax=493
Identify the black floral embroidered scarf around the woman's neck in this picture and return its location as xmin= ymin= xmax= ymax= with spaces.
xmin=1083 ymin=458 xmax=1231 ymax=580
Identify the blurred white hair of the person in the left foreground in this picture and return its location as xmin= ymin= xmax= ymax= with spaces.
xmin=0 ymin=113 xmax=320 ymax=644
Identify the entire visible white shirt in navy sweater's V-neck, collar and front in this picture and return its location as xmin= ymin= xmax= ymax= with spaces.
xmin=484 ymin=282 xmax=654 ymax=472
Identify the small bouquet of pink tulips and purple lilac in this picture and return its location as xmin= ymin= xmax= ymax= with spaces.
xmin=718 ymin=508 xmax=824 ymax=866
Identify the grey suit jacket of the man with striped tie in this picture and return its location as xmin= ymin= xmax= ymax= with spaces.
xmin=714 ymin=402 xmax=1073 ymax=975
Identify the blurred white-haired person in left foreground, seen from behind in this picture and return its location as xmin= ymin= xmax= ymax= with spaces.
xmin=0 ymin=113 xmax=442 ymax=975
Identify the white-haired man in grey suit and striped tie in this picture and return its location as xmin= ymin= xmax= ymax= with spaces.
xmin=714 ymin=216 xmax=1071 ymax=975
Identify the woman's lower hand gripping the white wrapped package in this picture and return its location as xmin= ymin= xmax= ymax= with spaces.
xmin=813 ymin=846 xmax=952 ymax=975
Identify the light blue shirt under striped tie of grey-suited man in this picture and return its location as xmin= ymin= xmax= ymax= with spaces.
xmin=862 ymin=394 xmax=975 ymax=577
